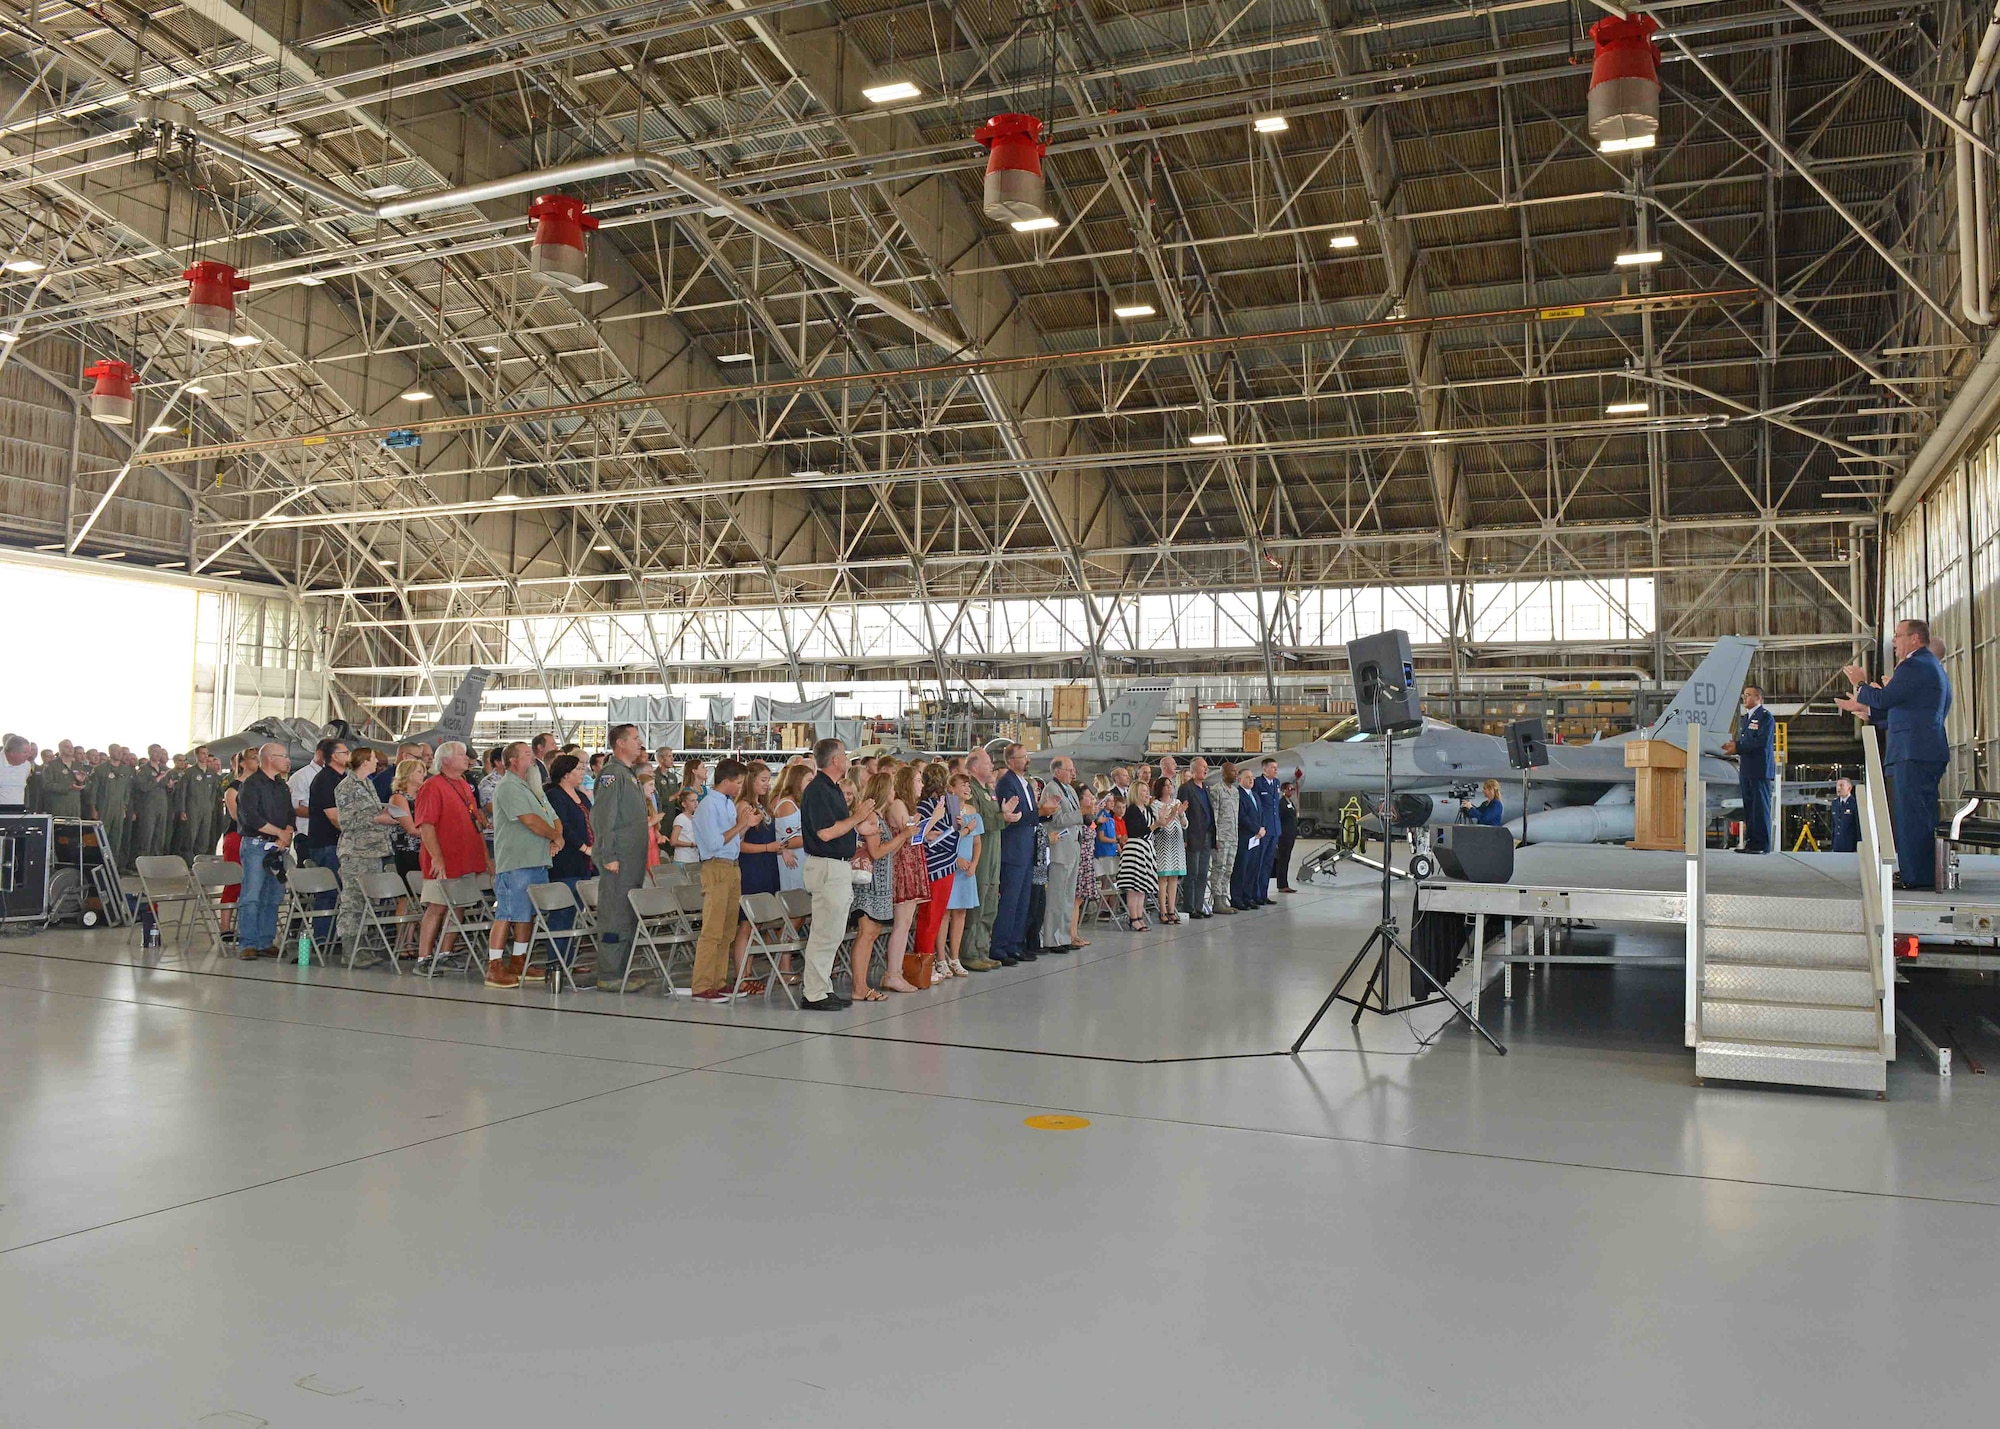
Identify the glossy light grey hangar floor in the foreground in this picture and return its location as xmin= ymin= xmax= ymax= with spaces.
xmin=0 ymin=883 xmax=2000 ymax=1427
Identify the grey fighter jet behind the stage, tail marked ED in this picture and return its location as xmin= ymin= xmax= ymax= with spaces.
xmin=1276 ymin=636 xmax=1756 ymax=843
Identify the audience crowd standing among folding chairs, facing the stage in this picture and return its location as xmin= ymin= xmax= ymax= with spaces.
xmin=0 ymin=725 xmax=1298 ymax=1011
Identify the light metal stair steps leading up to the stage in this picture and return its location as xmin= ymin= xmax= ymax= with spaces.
xmin=1694 ymin=891 xmax=1888 ymax=1091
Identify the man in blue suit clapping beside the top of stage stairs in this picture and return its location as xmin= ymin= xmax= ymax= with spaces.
xmin=1840 ymin=620 xmax=1952 ymax=889
